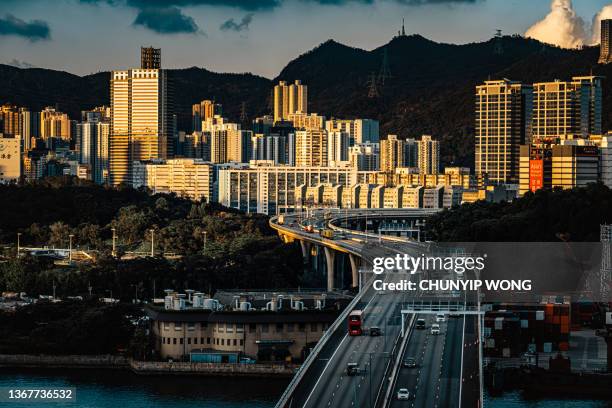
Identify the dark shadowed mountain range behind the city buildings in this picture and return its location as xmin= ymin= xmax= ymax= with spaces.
xmin=0 ymin=35 xmax=612 ymax=166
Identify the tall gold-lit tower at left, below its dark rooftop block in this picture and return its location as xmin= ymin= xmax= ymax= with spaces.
xmin=109 ymin=69 xmax=174 ymax=186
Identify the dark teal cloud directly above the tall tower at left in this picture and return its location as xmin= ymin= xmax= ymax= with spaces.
xmin=133 ymin=7 xmax=200 ymax=34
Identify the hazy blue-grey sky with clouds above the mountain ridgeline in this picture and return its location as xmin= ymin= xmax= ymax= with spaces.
xmin=0 ymin=0 xmax=612 ymax=78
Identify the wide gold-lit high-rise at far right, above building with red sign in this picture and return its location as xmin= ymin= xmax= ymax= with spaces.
xmin=532 ymin=76 xmax=603 ymax=140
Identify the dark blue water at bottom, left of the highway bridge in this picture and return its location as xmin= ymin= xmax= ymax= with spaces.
xmin=0 ymin=370 xmax=289 ymax=408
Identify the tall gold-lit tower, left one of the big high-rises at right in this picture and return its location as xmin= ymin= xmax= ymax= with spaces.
xmin=475 ymin=79 xmax=533 ymax=184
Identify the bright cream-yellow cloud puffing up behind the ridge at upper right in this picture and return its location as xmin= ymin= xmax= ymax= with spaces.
xmin=525 ymin=0 xmax=587 ymax=48
